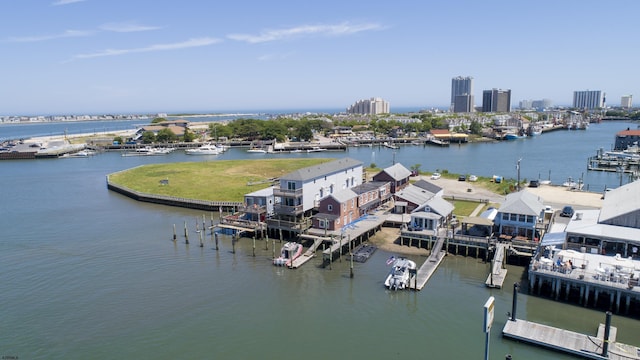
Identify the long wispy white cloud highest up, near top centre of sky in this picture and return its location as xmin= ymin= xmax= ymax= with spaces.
xmin=227 ymin=22 xmax=383 ymax=44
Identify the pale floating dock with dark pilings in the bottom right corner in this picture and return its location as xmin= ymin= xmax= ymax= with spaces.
xmin=502 ymin=319 xmax=640 ymax=360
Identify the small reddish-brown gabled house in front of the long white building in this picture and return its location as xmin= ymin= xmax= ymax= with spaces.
xmin=313 ymin=189 xmax=360 ymax=231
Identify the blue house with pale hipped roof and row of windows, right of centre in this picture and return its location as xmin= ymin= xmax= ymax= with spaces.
xmin=494 ymin=190 xmax=544 ymax=240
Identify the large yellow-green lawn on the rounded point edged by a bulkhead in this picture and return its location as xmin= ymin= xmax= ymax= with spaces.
xmin=109 ymin=158 xmax=334 ymax=202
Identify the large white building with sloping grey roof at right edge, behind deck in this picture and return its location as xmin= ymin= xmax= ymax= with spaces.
xmin=565 ymin=181 xmax=640 ymax=259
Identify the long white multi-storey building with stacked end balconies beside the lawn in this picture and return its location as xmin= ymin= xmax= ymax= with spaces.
xmin=267 ymin=158 xmax=363 ymax=237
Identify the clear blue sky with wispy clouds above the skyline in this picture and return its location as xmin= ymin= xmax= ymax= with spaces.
xmin=0 ymin=0 xmax=640 ymax=115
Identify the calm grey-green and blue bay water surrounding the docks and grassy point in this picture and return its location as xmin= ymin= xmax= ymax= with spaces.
xmin=0 ymin=123 xmax=640 ymax=359
